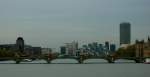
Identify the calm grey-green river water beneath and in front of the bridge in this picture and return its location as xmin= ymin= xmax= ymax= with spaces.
xmin=0 ymin=60 xmax=150 ymax=77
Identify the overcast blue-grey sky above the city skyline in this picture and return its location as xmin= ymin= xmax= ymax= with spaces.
xmin=0 ymin=0 xmax=150 ymax=48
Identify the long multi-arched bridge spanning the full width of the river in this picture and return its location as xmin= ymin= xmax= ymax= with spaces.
xmin=0 ymin=55 xmax=150 ymax=64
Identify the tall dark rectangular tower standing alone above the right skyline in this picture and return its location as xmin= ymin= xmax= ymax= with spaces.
xmin=120 ymin=22 xmax=131 ymax=45
